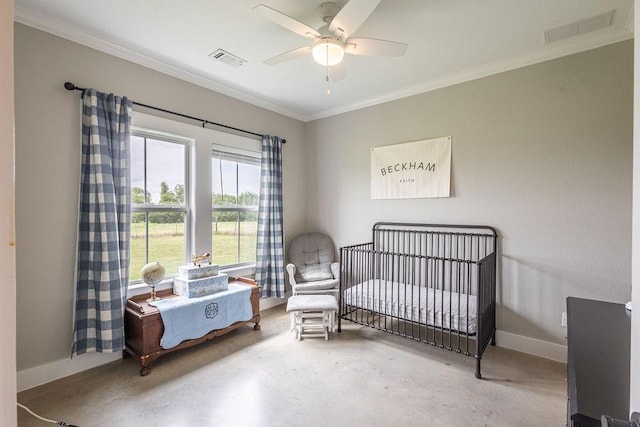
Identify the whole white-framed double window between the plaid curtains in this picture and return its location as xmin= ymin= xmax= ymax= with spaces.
xmin=130 ymin=110 xmax=261 ymax=289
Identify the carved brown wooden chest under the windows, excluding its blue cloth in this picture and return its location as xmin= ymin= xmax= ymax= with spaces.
xmin=123 ymin=278 xmax=260 ymax=376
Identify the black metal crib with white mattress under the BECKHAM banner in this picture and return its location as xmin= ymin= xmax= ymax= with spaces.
xmin=338 ymin=222 xmax=498 ymax=378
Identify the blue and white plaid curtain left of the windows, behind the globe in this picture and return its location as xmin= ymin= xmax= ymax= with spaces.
xmin=71 ymin=89 xmax=131 ymax=357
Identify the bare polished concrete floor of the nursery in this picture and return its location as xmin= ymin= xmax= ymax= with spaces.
xmin=18 ymin=306 xmax=566 ymax=427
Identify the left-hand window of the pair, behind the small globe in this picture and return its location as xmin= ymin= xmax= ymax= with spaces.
xmin=129 ymin=129 xmax=190 ymax=282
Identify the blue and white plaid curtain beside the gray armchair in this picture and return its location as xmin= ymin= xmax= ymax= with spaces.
xmin=256 ymin=135 xmax=285 ymax=298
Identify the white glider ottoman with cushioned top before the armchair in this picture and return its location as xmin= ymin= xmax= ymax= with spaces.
xmin=287 ymin=295 xmax=338 ymax=340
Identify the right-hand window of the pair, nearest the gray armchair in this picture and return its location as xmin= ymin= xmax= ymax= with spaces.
xmin=211 ymin=146 xmax=260 ymax=266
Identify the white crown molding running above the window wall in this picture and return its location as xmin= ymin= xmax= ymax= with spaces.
xmin=14 ymin=6 xmax=304 ymax=121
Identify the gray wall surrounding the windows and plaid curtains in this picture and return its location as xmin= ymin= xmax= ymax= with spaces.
xmin=15 ymin=24 xmax=306 ymax=371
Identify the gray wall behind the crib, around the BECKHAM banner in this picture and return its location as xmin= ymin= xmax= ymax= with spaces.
xmin=305 ymin=42 xmax=633 ymax=345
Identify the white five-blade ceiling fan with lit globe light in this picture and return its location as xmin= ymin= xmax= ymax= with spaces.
xmin=254 ymin=0 xmax=409 ymax=80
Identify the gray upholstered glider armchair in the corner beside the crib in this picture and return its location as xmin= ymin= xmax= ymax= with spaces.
xmin=287 ymin=232 xmax=340 ymax=296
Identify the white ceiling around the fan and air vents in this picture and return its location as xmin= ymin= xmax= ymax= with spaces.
xmin=15 ymin=0 xmax=633 ymax=121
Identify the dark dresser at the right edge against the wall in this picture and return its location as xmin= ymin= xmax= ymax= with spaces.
xmin=567 ymin=297 xmax=631 ymax=427
